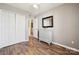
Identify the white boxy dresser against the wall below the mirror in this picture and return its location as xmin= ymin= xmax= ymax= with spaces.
xmin=39 ymin=29 xmax=53 ymax=45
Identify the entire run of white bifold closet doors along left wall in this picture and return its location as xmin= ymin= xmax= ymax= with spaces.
xmin=0 ymin=10 xmax=25 ymax=48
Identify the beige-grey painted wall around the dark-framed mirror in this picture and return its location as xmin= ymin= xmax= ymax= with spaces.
xmin=36 ymin=3 xmax=79 ymax=49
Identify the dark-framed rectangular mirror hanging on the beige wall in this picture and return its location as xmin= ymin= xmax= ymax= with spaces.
xmin=42 ymin=16 xmax=53 ymax=28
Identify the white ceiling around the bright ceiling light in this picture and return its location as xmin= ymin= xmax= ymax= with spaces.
xmin=8 ymin=3 xmax=62 ymax=15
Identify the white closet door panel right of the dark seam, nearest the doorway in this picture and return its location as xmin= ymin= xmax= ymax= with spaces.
xmin=16 ymin=14 xmax=25 ymax=42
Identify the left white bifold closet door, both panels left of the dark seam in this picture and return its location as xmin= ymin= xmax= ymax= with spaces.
xmin=1 ymin=10 xmax=16 ymax=47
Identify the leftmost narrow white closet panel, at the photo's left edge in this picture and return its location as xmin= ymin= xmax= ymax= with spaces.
xmin=1 ymin=11 xmax=9 ymax=47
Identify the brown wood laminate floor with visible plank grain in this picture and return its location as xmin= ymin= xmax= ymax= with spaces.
xmin=0 ymin=37 xmax=79 ymax=55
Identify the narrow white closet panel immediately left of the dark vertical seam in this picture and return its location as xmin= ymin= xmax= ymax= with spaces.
xmin=8 ymin=11 xmax=16 ymax=44
